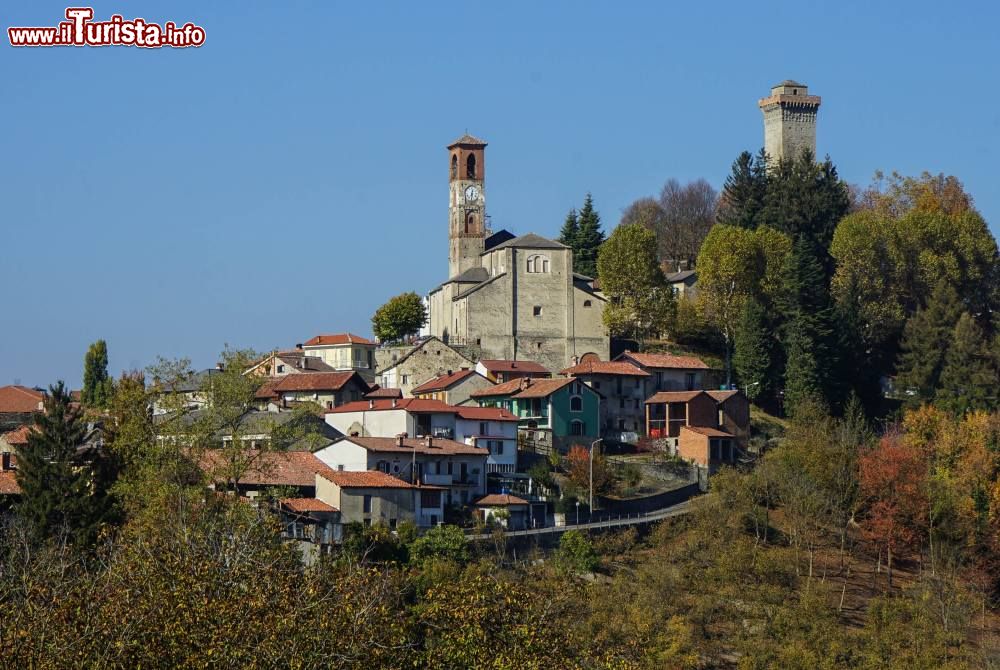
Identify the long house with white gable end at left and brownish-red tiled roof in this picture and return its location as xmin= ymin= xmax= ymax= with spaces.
xmin=315 ymin=435 xmax=489 ymax=505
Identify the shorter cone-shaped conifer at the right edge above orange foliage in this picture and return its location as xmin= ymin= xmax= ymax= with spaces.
xmin=936 ymin=312 xmax=997 ymax=415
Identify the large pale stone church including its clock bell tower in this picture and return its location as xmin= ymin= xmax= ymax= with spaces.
xmin=428 ymin=135 xmax=609 ymax=370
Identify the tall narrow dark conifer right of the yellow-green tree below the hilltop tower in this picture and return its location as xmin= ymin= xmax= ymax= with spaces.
xmin=781 ymin=237 xmax=840 ymax=411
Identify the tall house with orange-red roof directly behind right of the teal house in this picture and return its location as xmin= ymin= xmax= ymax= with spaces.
xmin=560 ymin=359 xmax=650 ymax=444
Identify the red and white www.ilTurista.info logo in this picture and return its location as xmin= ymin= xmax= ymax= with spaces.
xmin=7 ymin=7 xmax=205 ymax=49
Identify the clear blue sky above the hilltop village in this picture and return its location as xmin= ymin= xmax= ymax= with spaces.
xmin=0 ymin=1 xmax=1000 ymax=386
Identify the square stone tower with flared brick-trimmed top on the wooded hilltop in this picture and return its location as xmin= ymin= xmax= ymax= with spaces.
xmin=757 ymin=79 xmax=820 ymax=163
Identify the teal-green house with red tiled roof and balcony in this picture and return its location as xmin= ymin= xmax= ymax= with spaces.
xmin=472 ymin=378 xmax=601 ymax=453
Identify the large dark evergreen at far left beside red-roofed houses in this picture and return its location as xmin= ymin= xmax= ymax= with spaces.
xmin=17 ymin=382 xmax=116 ymax=545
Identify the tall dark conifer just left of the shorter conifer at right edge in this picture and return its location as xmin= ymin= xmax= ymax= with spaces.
xmin=896 ymin=281 xmax=962 ymax=407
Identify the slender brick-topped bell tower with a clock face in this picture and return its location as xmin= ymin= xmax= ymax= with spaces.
xmin=448 ymin=134 xmax=486 ymax=277
